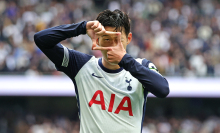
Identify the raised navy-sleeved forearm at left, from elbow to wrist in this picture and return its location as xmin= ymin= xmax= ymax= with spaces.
xmin=34 ymin=21 xmax=87 ymax=49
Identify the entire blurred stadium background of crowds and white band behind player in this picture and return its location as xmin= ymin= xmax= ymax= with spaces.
xmin=0 ymin=0 xmax=220 ymax=133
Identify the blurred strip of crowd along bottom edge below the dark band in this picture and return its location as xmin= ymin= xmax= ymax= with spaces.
xmin=0 ymin=114 xmax=220 ymax=133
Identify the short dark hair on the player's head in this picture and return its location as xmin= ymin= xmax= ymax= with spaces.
xmin=96 ymin=9 xmax=131 ymax=36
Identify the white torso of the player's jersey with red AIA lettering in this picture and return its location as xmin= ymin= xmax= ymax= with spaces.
xmin=75 ymin=57 xmax=146 ymax=133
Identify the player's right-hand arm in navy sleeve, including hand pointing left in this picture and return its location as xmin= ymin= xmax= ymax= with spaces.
xmin=93 ymin=32 xmax=169 ymax=98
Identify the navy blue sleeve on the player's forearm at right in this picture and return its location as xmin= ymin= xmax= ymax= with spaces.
xmin=119 ymin=54 xmax=170 ymax=98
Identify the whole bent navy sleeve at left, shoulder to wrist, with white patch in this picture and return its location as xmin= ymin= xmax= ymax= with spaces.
xmin=34 ymin=21 xmax=92 ymax=78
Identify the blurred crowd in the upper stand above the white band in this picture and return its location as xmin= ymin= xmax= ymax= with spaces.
xmin=0 ymin=0 xmax=220 ymax=77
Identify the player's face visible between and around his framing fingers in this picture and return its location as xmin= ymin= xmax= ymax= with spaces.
xmin=97 ymin=26 xmax=132 ymax=64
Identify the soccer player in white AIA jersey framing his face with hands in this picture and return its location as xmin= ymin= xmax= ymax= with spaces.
xmin=34 ymin=10 xmax=169 ymax=133
